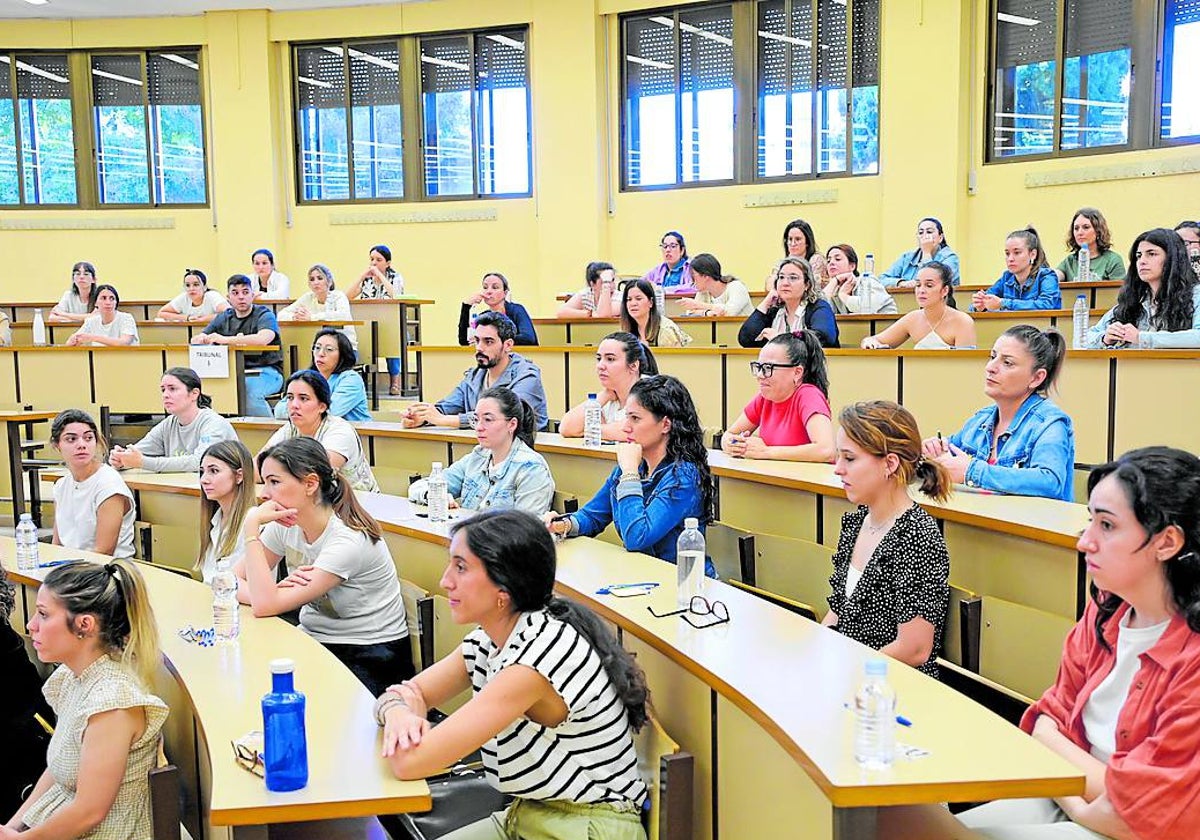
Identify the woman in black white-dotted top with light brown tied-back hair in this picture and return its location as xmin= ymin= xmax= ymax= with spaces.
xmin=821 ymin=400 xmax=950 ymax=678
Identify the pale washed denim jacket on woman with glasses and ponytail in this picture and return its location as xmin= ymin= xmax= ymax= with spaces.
xmin=408 ymin=438 xmax=554 ymax=516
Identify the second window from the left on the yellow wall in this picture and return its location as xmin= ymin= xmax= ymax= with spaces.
xmin=294 ymin=29 xmax=533 ymax=202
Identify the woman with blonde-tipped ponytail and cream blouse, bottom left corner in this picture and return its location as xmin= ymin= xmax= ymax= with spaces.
xmin=0 ymin=560 xmax=168 ymax=840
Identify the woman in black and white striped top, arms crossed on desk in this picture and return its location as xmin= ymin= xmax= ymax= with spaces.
xmin=376 ymin=510 xmax=648 ymax=840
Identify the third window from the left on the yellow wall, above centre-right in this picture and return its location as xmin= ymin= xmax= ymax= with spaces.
xmin=622 ymin=0 xmax=880 ymax=188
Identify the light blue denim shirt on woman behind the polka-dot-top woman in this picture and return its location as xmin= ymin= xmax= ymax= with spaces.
xmin=950 ymin=394 xmax=1075 ymax=502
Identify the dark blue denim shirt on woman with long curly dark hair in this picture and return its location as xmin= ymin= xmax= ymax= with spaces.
xmin=571 ymin=461 xmax=712 ymax=576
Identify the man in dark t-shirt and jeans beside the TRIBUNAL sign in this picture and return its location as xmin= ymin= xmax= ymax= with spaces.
xmin=192 ymin=274 xmax=283 ymax=418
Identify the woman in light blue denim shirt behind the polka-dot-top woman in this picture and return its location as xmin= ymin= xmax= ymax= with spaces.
xmin=924 ymin=324 xmax=1075 ymax=502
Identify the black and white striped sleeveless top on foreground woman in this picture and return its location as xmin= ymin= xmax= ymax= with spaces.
xmin=462 ymin=610 xmax=646 ymax=806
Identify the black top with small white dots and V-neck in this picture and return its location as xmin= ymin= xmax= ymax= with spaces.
xmin=828 ymin=504 xmax=950 ymax=677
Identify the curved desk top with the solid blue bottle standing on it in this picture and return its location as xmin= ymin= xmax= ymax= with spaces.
xmin=0 ymin=542 xmax=432 ymax=826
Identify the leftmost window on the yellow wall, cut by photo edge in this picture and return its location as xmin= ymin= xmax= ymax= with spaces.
xmin=0 ymin=49 xmax=208 ymax=206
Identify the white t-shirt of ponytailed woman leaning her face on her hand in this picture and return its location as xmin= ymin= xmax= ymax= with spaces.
xmin=259 ymin=515 xmax=408 ymax=644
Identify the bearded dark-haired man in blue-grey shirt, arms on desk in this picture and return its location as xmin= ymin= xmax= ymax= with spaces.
xmin=405 ymin=309 xmax=550 ymax=431
